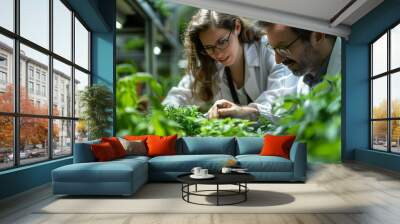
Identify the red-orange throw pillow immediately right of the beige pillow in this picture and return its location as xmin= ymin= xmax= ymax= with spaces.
xmin=147 ymin=135 xmax=178 ymax=156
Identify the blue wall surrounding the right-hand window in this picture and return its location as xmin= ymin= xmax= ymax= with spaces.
xmin=342 ymin=0 xmax=400 ymax=170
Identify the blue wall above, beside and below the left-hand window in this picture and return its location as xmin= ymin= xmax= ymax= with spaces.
xmin=0 ymin=0 xmax=116 ymax=199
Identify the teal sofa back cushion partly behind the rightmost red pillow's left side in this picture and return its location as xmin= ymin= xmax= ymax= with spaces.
xmin=236 ymin=137 xmax=264 ymax=155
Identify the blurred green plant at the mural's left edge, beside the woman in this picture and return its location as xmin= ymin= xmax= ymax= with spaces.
xmin=116 ymin=64 xmax=182 ymax=136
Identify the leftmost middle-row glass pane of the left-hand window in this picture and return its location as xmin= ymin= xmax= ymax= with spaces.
xmin=0 ymin=35 xmax=14 ymax=112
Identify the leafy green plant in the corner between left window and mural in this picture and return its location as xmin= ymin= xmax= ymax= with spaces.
xmin=79 ymin=84 xmax=113 ymax=139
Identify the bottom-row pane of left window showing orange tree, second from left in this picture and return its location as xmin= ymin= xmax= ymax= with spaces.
xmin=19 ymin=117 xmax=49 ymax=164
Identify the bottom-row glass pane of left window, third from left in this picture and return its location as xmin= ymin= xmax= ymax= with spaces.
xmin=53 ymin=120 xmax=72 ymax=157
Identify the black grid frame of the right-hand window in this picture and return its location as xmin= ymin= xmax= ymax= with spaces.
xmin=368 ymin=21 xmax=400 ymax=155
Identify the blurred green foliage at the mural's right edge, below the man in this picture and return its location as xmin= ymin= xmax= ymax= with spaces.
xmin=273 ymin=74 xmax=341 ymax=162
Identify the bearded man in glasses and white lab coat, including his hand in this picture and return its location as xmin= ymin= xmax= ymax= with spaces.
xmin=210 ymin=22 xmax=341 ymax=120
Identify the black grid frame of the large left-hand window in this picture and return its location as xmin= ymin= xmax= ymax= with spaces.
xmin=0 ymin=0 xmax=93 ymax=172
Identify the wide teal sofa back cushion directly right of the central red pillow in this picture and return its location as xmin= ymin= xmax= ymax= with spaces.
xmin=178 ymin=137 xmax=235 ymax=155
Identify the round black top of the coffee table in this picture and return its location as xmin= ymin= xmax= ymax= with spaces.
xmin=177 ymin=173 xmax=255 ymax=184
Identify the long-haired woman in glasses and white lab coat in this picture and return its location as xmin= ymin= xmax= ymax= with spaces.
xmin=163 ymin=9 xmax=297 ymax=120
